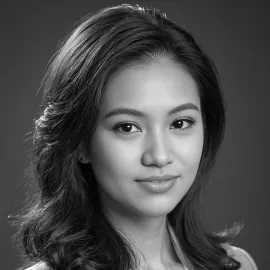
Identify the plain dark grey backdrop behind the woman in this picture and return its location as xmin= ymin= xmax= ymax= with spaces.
xmin=0 ymin=0 xmax=270 ymax=269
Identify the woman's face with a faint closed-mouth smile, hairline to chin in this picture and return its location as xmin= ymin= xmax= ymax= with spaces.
xmin=88 ymin=58 xmax=203 ymax=217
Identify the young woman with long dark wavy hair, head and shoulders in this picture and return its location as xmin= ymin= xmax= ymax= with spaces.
xmin=10 ymin=4 xmax=257 ymax=270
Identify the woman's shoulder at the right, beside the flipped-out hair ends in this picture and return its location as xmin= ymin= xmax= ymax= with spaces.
xmin=226 ymin=246 xmax=258 ymax=270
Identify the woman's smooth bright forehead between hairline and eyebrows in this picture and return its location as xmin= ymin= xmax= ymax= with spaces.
xmin=100 ymin=58 xmax=200 ymax=114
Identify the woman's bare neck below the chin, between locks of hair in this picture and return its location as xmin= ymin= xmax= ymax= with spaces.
xmin=105 ymin=209 xmax=178 ymax=265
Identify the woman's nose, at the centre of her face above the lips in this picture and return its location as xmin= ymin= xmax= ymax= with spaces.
xmin=142 ymin=132 xmax=174 ymax=168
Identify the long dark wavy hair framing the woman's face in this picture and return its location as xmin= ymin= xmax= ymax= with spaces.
xmin=11 ymin=4 xmax=243 ymax=270
